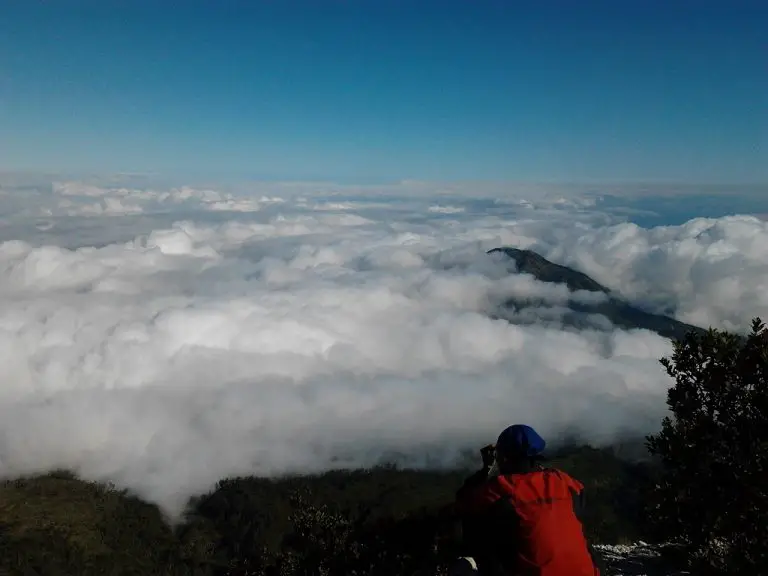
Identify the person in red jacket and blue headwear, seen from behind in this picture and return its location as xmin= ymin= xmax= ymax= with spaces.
xmin=452 ymin=424 xmax=605 ymax=576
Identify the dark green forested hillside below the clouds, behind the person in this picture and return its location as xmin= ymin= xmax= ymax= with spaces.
xmin=0 ymin=447 xmax=651 ymax=576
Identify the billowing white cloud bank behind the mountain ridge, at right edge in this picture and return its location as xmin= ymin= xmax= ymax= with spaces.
xmin=537 ymin=215 xmax=768 ymax=331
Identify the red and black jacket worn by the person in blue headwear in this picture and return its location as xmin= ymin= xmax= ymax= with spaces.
xmin=456 ymin=469 xmax=600 ymax=576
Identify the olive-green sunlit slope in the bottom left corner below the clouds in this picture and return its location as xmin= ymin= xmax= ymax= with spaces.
xmin=0 ymin=472 xmax=213 ymax=576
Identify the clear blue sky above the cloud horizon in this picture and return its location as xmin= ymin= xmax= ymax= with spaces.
xmin=0 ymin=0 xmax=768 ymax=182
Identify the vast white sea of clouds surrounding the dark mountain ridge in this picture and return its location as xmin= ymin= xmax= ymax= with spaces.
xmin=0 ymin=181 xmax=768 ymax=513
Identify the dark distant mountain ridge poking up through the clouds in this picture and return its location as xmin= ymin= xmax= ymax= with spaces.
xmin=488 ymin=248 xmax=705 ymax=340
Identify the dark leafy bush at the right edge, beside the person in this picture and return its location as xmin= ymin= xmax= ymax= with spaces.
xmin=648 ymin=318 xmax=768 ymax=574
